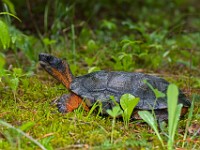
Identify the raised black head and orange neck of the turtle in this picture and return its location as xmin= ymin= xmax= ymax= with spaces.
xmin=39 ymin=53 xmax=73 ymax=89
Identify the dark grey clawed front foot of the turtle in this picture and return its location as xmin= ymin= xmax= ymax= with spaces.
xmin=56 ymin=94 xmax=70 ymax=113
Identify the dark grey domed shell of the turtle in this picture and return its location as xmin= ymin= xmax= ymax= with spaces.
xmin=70 ymin=71 xmax=190 ymax=110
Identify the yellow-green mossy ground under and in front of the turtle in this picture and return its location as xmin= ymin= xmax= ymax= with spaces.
xmin=0 ymin=58 xmax=200 ymax=149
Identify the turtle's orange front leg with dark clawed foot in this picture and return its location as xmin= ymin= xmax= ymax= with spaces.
xmin=57 ymin=93 xmax=89 ymax=113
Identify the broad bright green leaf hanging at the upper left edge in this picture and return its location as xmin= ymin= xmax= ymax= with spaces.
xmin=0 ymin=20 xmax=10 ymax=49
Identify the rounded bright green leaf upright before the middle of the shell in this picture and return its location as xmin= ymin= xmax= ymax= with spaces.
xmin=120 ymin=94 xmax=140 ymax=129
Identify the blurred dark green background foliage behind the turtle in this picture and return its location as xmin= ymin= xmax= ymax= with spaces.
xmin=0 ymin=0 xmax=200 ymax=86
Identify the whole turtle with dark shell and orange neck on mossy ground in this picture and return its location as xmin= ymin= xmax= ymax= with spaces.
xmin=39 ymin=53 xmax=191 ymax=120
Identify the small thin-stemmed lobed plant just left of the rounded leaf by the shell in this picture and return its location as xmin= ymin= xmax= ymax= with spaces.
xmin=107 ymin=106 xmax=122 ymax=144
